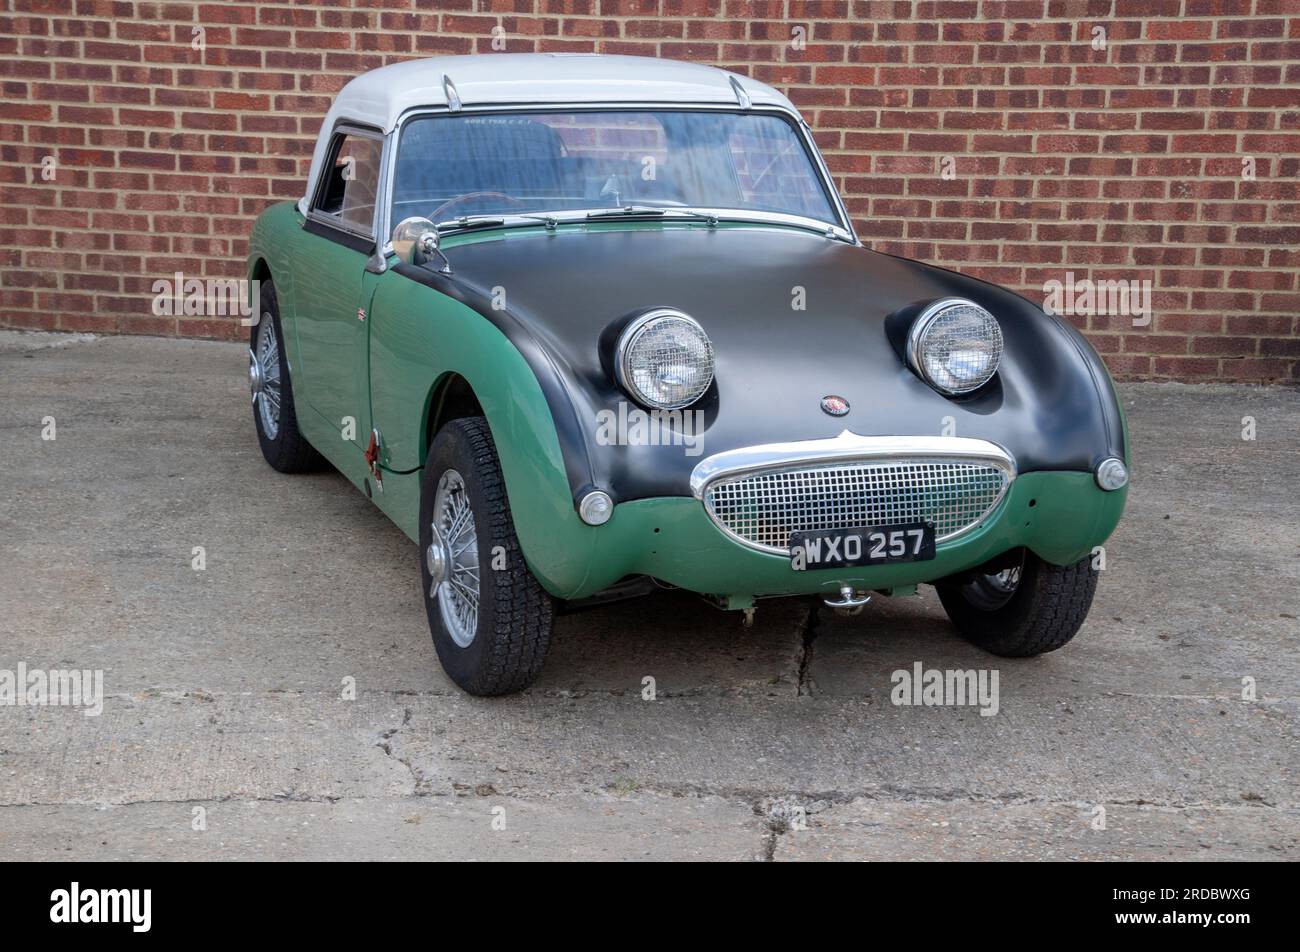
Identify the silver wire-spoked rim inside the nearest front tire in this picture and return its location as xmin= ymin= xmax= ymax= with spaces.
xmin=425 ymin=469 xmax=480 ymax=648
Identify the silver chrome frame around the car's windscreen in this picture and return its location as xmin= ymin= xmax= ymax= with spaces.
xmin=376 ymin=101 xmax=862 ymax=258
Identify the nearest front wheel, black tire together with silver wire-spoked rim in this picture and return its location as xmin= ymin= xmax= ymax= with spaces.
xmin=420 ymin=416 xmax=554 ymax=696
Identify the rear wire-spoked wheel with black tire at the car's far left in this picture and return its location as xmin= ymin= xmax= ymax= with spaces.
xmin=248 ymin=281 xmax=321 ymax=472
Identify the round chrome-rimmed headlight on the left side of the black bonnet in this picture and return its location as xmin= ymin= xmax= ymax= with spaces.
xmin=615 ymin=308 xmax=714 ymax=410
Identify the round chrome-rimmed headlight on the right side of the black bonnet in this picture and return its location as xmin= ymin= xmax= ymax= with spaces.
xmin=907 ymin=299 xmax=1002 ymax=394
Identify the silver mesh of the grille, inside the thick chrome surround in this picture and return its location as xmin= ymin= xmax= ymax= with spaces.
xmin=703 ymin=459 xmax=1011 ymax=553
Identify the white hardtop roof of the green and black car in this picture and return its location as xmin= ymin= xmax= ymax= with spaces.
xmin=328 ymin=53 xmax=794 ymax=133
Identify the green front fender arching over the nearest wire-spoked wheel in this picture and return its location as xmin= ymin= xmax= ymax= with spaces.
xmin=371 ymin=272 xmax=597 ymax=598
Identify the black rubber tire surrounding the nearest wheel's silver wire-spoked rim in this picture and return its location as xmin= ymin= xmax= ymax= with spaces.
xmin=420 ymin=416 xmax=554 ymax=697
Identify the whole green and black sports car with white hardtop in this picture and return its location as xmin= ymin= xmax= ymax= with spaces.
xmin=248 ymin=53 xmax=1128 ymax=694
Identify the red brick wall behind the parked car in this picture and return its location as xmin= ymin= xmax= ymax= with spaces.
xmin=0 ymin=0 xmax=1300 ymax=381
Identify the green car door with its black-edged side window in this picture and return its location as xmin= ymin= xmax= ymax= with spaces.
xmin=293 ymin=126 xmax=384 ymax=456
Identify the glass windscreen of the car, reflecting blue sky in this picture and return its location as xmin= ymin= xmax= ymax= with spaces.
xmin=393 ymin=111 xmax=836 ymax=224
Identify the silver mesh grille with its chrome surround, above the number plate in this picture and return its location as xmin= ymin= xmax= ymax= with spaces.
xmin=692 ymin=430 xmax=1015 ymax=555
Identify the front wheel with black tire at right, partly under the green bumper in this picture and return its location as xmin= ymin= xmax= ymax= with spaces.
xmin=935 ymin=551 xmax=1097 ymax=658
